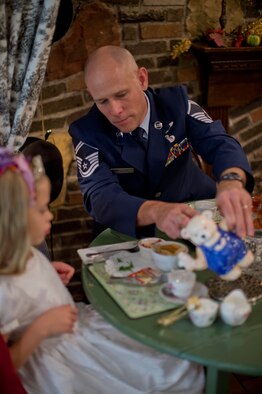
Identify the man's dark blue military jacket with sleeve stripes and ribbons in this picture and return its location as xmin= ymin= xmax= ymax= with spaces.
xmin=69 ymin=86 xmax=253 ymax=236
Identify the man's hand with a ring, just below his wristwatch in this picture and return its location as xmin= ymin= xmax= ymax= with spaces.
xmin=216 ymin=181 xmax=254 ymax=237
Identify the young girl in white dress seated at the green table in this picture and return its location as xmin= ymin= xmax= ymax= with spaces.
xmin=0 ymin=148 xmax=204 ymax=394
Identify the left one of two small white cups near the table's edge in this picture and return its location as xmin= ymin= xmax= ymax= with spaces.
xmin=189 ymin=298 xmax=219 ymax=327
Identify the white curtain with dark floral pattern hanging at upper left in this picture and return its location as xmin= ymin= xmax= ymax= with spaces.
xmin=0 ymin=0 xmax=60 ymax=150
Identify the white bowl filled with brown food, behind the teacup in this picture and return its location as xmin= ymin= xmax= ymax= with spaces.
xmin=151 ymin=241 xmax=188 ymax=272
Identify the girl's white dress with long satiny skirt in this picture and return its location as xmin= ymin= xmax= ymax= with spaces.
xmin=0 ymin=248 xmax=204 ymax=394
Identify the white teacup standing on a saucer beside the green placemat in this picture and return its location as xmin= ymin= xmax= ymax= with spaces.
xmin=167 ymin=269 xmax=196 ymax=299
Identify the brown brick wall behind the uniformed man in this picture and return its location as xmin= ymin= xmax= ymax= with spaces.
xmin=27 ymin=0 xmax=262 ymax=296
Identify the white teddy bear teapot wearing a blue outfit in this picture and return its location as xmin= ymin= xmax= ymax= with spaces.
xmin=178 ymin=211 xmax=254 ymax=281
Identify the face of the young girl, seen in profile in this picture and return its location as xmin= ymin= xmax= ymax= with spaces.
xmin=28 ymin=176 xmax=53 ymax=245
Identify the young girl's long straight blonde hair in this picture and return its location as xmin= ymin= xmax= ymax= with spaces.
xmin=0 ymin=169 xmax=31 ymax=275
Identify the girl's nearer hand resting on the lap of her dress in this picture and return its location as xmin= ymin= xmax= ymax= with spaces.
xmin=33 ymin=305 xmax=77 ymax=339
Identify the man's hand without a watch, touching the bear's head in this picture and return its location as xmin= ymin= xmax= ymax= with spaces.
xmin=137 ymin=201 xmax=198 ymax=239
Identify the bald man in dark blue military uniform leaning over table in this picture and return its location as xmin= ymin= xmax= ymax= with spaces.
xmin=69 ymin=46 xmax=254 ymax=238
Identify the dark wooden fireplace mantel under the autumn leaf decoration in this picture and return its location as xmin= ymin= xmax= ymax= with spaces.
xmin=191 ymin=42 xmax=262 ymax=127
